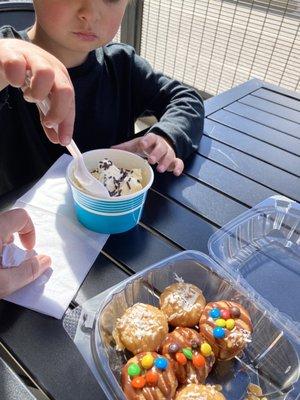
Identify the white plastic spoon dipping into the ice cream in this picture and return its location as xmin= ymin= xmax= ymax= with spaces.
xmin=25 ymin=76 xmax=110 ymax=197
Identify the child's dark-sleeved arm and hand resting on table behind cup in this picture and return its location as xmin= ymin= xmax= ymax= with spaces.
xmin=112 ymin=47 xmax=204 ymax=175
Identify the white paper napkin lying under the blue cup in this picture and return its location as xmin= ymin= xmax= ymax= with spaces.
xmin=6 ymin=154 xmax=109 ymax=319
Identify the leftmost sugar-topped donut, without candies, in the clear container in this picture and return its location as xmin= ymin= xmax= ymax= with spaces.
xmin=113 ymin=303 xmax=168 ymax=354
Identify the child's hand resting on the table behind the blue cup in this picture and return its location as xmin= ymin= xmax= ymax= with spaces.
xmin=112 ymin=132 xmax=184 ymax=176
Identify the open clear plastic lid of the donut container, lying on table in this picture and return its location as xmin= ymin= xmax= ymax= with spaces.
xmin=208 ymin=196 xmax=300 ymax=344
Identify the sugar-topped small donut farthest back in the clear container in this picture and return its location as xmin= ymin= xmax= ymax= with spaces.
xmin=160 ymin=282 xmax=206 ymax=327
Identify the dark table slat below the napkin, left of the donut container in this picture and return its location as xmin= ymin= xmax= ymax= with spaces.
xmin=0 ymin=301 xmax=105 ymax=400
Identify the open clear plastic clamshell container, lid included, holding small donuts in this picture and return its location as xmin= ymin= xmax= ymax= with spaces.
xmin=91 ymin=197 xmax=300 ymax=400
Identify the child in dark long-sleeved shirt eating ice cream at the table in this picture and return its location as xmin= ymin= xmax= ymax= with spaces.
xmin=0 ymin=0 xmax=204 ymax=195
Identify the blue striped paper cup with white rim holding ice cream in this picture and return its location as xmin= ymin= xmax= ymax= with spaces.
xmin=67 ymin=149 xmax=154 ymax=233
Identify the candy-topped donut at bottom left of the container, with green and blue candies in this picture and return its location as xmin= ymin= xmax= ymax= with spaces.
xmin=121 ymin=352 xmax=178 ymax=400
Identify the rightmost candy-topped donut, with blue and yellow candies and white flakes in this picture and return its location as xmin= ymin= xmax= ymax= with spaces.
xmin=199 ymin=300 xmax=253 ymax=360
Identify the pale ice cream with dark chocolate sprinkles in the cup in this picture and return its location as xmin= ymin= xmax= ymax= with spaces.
xmin=91 ymin=158 xmax=143 ymax=197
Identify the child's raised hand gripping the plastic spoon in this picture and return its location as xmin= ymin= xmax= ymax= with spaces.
xmin=0 ymin=39 xmax=75 ymax=145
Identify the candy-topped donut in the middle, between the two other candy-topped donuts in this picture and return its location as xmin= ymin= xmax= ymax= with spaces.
xmin=161 ymin=327 xmax=215 ymax=384
